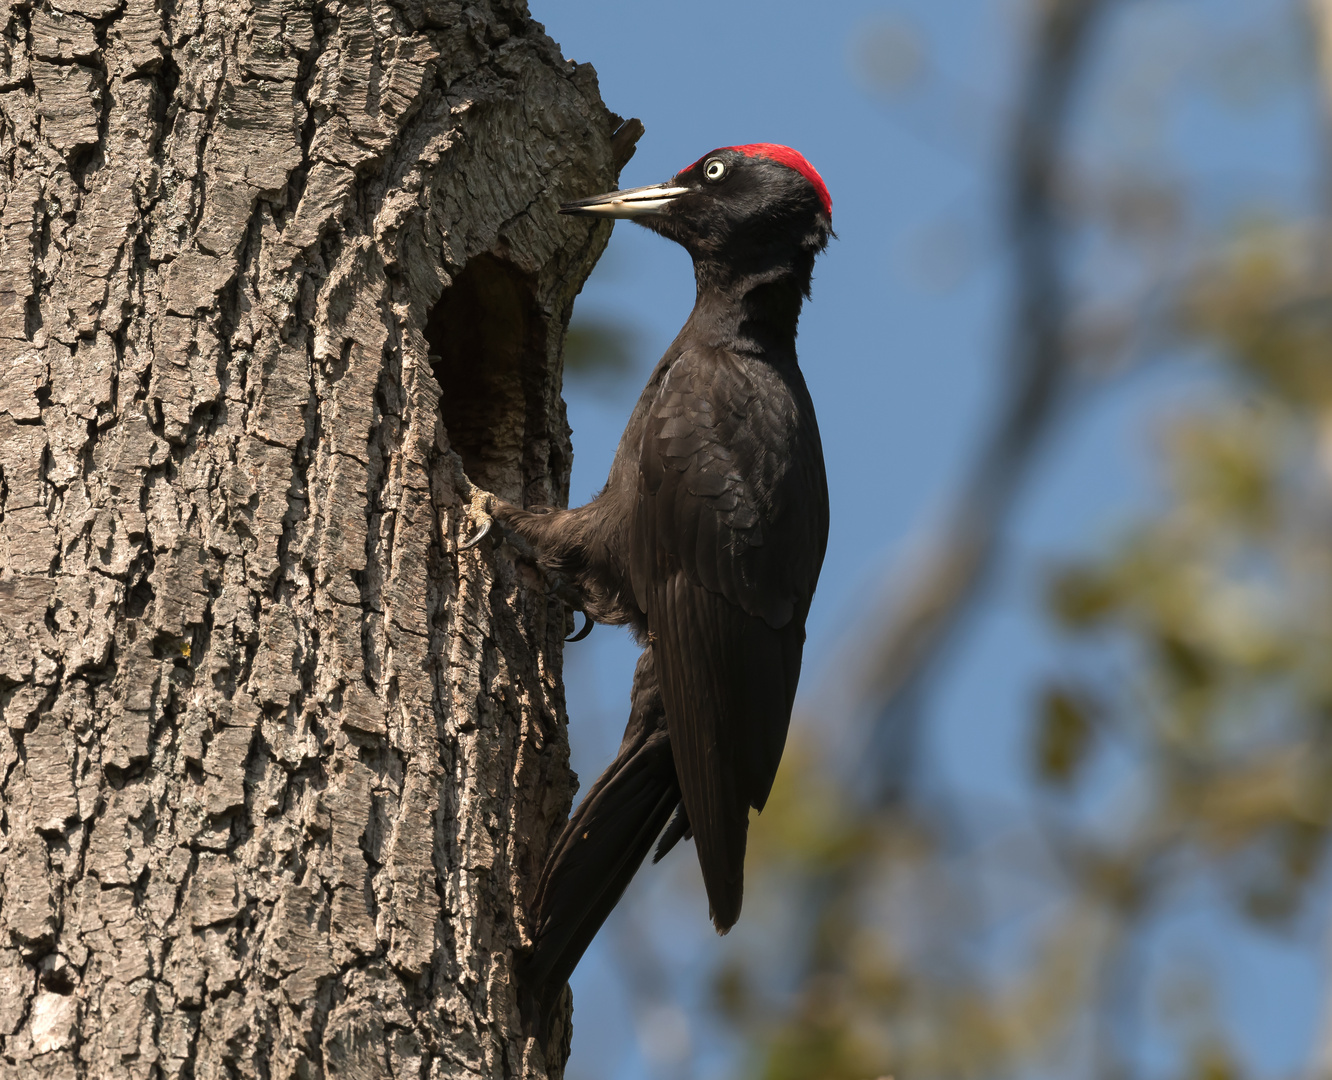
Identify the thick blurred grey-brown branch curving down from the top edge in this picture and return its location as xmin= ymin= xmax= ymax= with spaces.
xmin=867 ymin=0 xmax=1110 ymax=800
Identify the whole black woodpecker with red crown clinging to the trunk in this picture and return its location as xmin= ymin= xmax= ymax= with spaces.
xmin=469 ymin=142 xmax=833 ymax=1017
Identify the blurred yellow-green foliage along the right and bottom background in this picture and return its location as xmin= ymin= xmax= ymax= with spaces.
xmin=717 ymin=211 xmax=1332 ymax=1080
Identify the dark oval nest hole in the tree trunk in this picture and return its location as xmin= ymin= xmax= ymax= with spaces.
xmin=425 ymin=256 xmax=546 ymax=499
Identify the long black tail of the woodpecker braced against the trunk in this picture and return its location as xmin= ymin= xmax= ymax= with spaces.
xmin=522 ymin=650 xmax=679 ymax=1040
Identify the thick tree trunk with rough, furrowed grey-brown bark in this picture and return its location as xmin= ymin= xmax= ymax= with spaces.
xmin=0 ymin=0 xmax=625 ymax=1077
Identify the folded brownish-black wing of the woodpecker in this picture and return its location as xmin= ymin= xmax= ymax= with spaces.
xmin=630 ymin=350 xmax=827 ymax=931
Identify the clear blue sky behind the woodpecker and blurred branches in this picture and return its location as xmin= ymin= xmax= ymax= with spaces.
xmin=531 ymin=0 xmax=1323 ymax=1080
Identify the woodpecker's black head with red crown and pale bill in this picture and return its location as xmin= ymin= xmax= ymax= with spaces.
xmin=559 ymin=142 xmax=833 ymax=281
